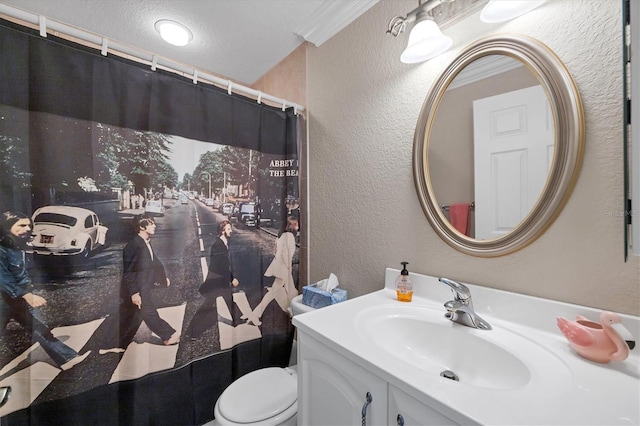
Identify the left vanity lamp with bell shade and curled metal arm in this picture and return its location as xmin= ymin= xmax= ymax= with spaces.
xmin=387 ymin=0 xmax=454 ymax=64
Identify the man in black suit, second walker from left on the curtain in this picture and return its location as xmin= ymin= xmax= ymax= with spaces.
xmin=100 ymin=215 xmax=180 ymax=353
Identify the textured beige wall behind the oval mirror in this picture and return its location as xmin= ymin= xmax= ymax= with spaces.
xmin=306 ymin=0 xmax=640 ymax=315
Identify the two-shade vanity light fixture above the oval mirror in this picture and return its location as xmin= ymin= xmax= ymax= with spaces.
xmin=387 ymin=0 xmax=545 ymax=64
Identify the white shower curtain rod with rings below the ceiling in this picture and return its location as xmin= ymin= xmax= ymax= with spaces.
xmin=0 ymin=3 xmax=304 ymax=114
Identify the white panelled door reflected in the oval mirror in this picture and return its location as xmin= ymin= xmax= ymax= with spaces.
xmin=473 ymin=85 xmax=554 ymax=239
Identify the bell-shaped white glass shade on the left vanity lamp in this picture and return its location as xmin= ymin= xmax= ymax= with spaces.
xmin=400 ymin=19 xmax=453 ymax=64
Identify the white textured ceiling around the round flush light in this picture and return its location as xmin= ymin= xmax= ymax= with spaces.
xmin=0 ymin=0 xmax=378 ymax=85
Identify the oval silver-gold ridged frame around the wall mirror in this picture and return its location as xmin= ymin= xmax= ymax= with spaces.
xmin=413 ymin=34 xmax=584 ymax=257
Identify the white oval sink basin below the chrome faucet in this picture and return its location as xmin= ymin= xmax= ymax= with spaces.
xmin=354 ymin=304 xmax=571 ymax=390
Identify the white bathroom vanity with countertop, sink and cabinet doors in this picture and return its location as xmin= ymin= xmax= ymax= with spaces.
xmin=293 ymin=269 xmax=640 ymax=425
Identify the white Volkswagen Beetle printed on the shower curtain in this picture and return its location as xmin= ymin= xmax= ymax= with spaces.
xmin=31 ymin=206 xmax=108 ymax=258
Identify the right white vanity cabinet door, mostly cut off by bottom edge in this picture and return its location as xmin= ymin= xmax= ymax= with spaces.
xmin=388 ymin=385 xmax=457 ymax=426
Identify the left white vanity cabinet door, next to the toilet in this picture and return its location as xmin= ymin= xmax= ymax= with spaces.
xmin=298 ymin=330 xmax=387 ymax=426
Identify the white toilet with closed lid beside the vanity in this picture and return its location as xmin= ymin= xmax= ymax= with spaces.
xmin=212 ymin=294 xmax=314 ymax=426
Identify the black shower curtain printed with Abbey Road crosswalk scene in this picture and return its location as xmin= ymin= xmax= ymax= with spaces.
xmin=0 ymin=21 xmax=299 ymax=425
